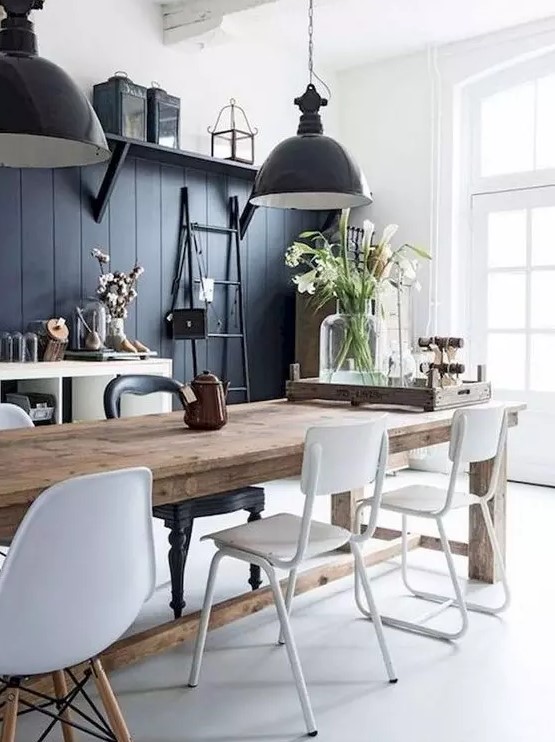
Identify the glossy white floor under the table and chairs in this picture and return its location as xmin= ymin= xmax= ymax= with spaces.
xmin=17 ymin=473 xmax=555 ymax=742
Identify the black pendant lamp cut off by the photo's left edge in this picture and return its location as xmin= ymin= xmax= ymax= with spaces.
xmin=0 ymin=0 xmax=110 ymax=168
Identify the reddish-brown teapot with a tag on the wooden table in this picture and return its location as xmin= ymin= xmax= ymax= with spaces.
xmin=181 ymin=371 xmax=229 ymax=430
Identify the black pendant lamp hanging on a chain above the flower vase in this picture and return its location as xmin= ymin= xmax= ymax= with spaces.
xmin=250 ymin=0 xmax=372 ymax=211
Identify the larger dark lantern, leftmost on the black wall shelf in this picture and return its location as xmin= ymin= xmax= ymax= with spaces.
xmin=93 ymin=72 xmax=147 ymax=142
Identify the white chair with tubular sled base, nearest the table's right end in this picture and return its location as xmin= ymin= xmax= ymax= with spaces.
xmin=355 ymin=404 xmax=510 ymax=640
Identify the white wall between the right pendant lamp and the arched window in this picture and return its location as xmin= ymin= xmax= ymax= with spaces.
xmin=338 ymin=18 xmax=555 ymax=336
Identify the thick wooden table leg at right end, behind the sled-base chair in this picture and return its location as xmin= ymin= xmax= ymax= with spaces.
xmin=468 ymin=449 xmax=507 ymax=584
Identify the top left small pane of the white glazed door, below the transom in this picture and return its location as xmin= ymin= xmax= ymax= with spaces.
xmin=488 ymin=209 xmax=526 ymax=268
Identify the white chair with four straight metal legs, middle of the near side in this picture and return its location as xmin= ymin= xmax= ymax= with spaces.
xmin=189 ymin=415 xmax=397 ymax=737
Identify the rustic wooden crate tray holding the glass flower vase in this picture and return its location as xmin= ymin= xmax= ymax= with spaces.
xmin=286 ymin=379 xmax=491 ymax=412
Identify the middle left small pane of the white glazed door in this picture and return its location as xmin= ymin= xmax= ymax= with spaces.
xmin=488 ymin=273 xmax=526 ymax=330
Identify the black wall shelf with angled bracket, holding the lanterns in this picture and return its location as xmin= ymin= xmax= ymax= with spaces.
xmin=92 ymin=134 xmax=258 ymax=224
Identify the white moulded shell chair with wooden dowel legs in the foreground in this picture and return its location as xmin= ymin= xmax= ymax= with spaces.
xmin=0 ymin=468 xmax=155 ymax=742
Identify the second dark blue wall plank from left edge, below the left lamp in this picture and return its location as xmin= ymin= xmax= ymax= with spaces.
xmin=21 ymin=170 xmax=56 ymax=329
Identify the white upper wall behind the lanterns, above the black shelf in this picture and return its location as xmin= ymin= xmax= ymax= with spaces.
xmin=35 ymin=0 xmax=337 ymax=162
